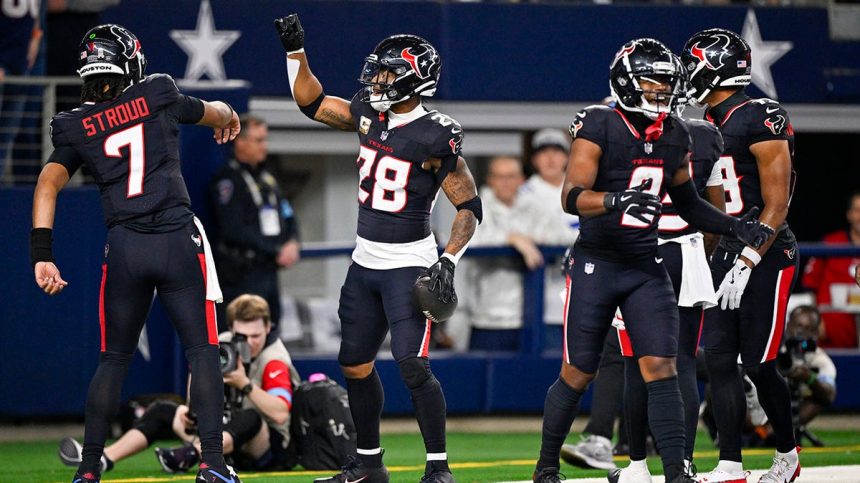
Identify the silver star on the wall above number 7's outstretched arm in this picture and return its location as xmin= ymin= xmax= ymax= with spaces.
xmin=170 ymin=0 xmax=242 ymax=81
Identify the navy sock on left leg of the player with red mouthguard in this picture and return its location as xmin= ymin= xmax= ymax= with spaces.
xmin=537 ymin=378 xmax=583 ymax=471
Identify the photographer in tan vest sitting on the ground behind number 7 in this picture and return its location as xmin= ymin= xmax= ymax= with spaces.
xmin=59 ymin=294 xmax=301 ymax=473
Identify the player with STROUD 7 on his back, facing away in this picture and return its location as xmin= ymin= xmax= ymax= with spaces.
xmin=30 ymin=24 xmax=240 ymax=483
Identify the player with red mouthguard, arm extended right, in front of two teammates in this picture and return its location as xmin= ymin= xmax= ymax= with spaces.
xmin=533 ymin=39 xmax=772 ymax=483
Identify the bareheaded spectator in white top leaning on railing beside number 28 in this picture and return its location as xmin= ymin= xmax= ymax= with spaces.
xmin=467 ymin=156 xmax=570 ymax=350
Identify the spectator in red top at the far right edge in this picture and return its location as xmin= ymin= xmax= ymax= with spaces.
xmin=803 ymin=191 xmax=860 ymax=347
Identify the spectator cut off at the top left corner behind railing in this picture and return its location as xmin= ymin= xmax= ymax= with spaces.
xmin=0 ymin=2 xmax=42 ymax=177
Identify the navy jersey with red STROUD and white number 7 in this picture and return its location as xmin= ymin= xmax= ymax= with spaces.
xmin=48 ymin=74 xmax=203 ymax=232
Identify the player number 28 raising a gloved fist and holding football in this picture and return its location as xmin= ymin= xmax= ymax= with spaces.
xmin=275 ymin=14 xmax=481 ymax=483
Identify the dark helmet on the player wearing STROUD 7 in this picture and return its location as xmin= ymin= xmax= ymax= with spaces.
xmin=78 ymin=24 xmax=146 ymax=85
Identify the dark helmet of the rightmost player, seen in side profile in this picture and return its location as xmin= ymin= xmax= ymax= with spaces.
xmin=681 ymin=29 xmax=752 ymax=106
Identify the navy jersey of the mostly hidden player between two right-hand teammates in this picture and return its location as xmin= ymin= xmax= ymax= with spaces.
xmin=658 ymin=119 xmax=724 ymax=239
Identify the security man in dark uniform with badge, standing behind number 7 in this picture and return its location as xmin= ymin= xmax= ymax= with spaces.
xmin=210 ymin=114 xmax=299 ymax=337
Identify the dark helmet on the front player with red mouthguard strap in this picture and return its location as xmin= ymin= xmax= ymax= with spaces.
xmin=609 ymin=38 xmax=683 ymax=119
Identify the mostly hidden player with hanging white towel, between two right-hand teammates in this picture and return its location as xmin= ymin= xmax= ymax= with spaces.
xmin=609 ymin=56 xmax=725 ymax=483
